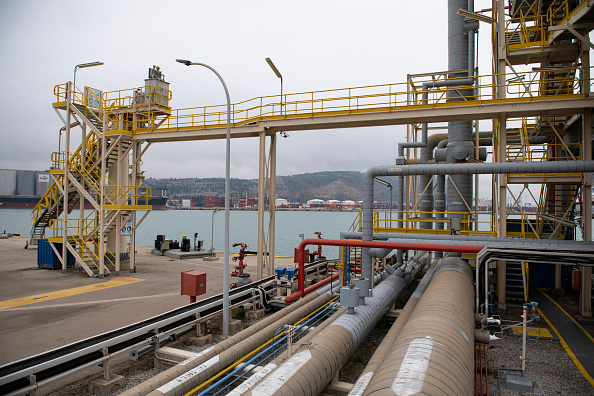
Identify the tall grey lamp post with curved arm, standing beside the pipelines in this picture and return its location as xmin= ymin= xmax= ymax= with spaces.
xmin=176 ymin=59 xmax=231 ymax=337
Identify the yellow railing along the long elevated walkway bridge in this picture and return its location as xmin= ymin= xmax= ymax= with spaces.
xmin=55 ymin=68 xmax=589 ymax=133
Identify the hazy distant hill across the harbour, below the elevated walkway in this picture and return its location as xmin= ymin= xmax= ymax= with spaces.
xmin=145 ymin=171 xmax=396 ymax=203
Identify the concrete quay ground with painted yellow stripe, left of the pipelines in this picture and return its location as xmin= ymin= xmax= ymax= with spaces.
xmin=0 ymin=237 xmax=293 ymax=365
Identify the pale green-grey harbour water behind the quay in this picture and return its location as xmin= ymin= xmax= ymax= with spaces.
xmin=0 ymin=209 xmax=357 ymax=258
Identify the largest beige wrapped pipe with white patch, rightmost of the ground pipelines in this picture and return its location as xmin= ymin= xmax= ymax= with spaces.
xmin=363 ymin=257 xmax=474 ymax=396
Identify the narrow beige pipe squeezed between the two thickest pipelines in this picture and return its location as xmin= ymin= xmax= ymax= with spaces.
xmin=348 ymin=264 xmax=439 ymax=396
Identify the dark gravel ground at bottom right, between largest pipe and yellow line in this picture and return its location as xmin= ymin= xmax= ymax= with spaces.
xmin=487 ymin=308 xmax=594 ymax=396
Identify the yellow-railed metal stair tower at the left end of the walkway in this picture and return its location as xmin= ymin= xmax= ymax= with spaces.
xmin=29 ymin=86 xmax=140 ymax=276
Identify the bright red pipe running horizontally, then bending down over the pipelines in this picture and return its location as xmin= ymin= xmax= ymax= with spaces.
xmin=285 ymin=238 xmax=483 ymax=303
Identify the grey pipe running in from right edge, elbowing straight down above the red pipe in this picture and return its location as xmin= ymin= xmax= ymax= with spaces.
xmin=361 ymin=160 xmax=594 ymax=277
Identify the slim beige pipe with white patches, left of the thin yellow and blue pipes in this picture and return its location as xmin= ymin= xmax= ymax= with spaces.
xmin=123 ymin=285 xmax=332 ymax=396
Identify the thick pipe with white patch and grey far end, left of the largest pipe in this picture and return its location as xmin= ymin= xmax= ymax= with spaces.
xmin=238 ymin=254 xmax=428 ymax=395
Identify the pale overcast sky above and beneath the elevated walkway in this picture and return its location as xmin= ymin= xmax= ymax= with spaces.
xmin=0 ymin=0 xmax=491 ymax=195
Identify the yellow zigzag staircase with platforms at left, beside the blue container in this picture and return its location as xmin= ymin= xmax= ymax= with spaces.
xmin=31 ymin=84 xmax=151 ymax=276
